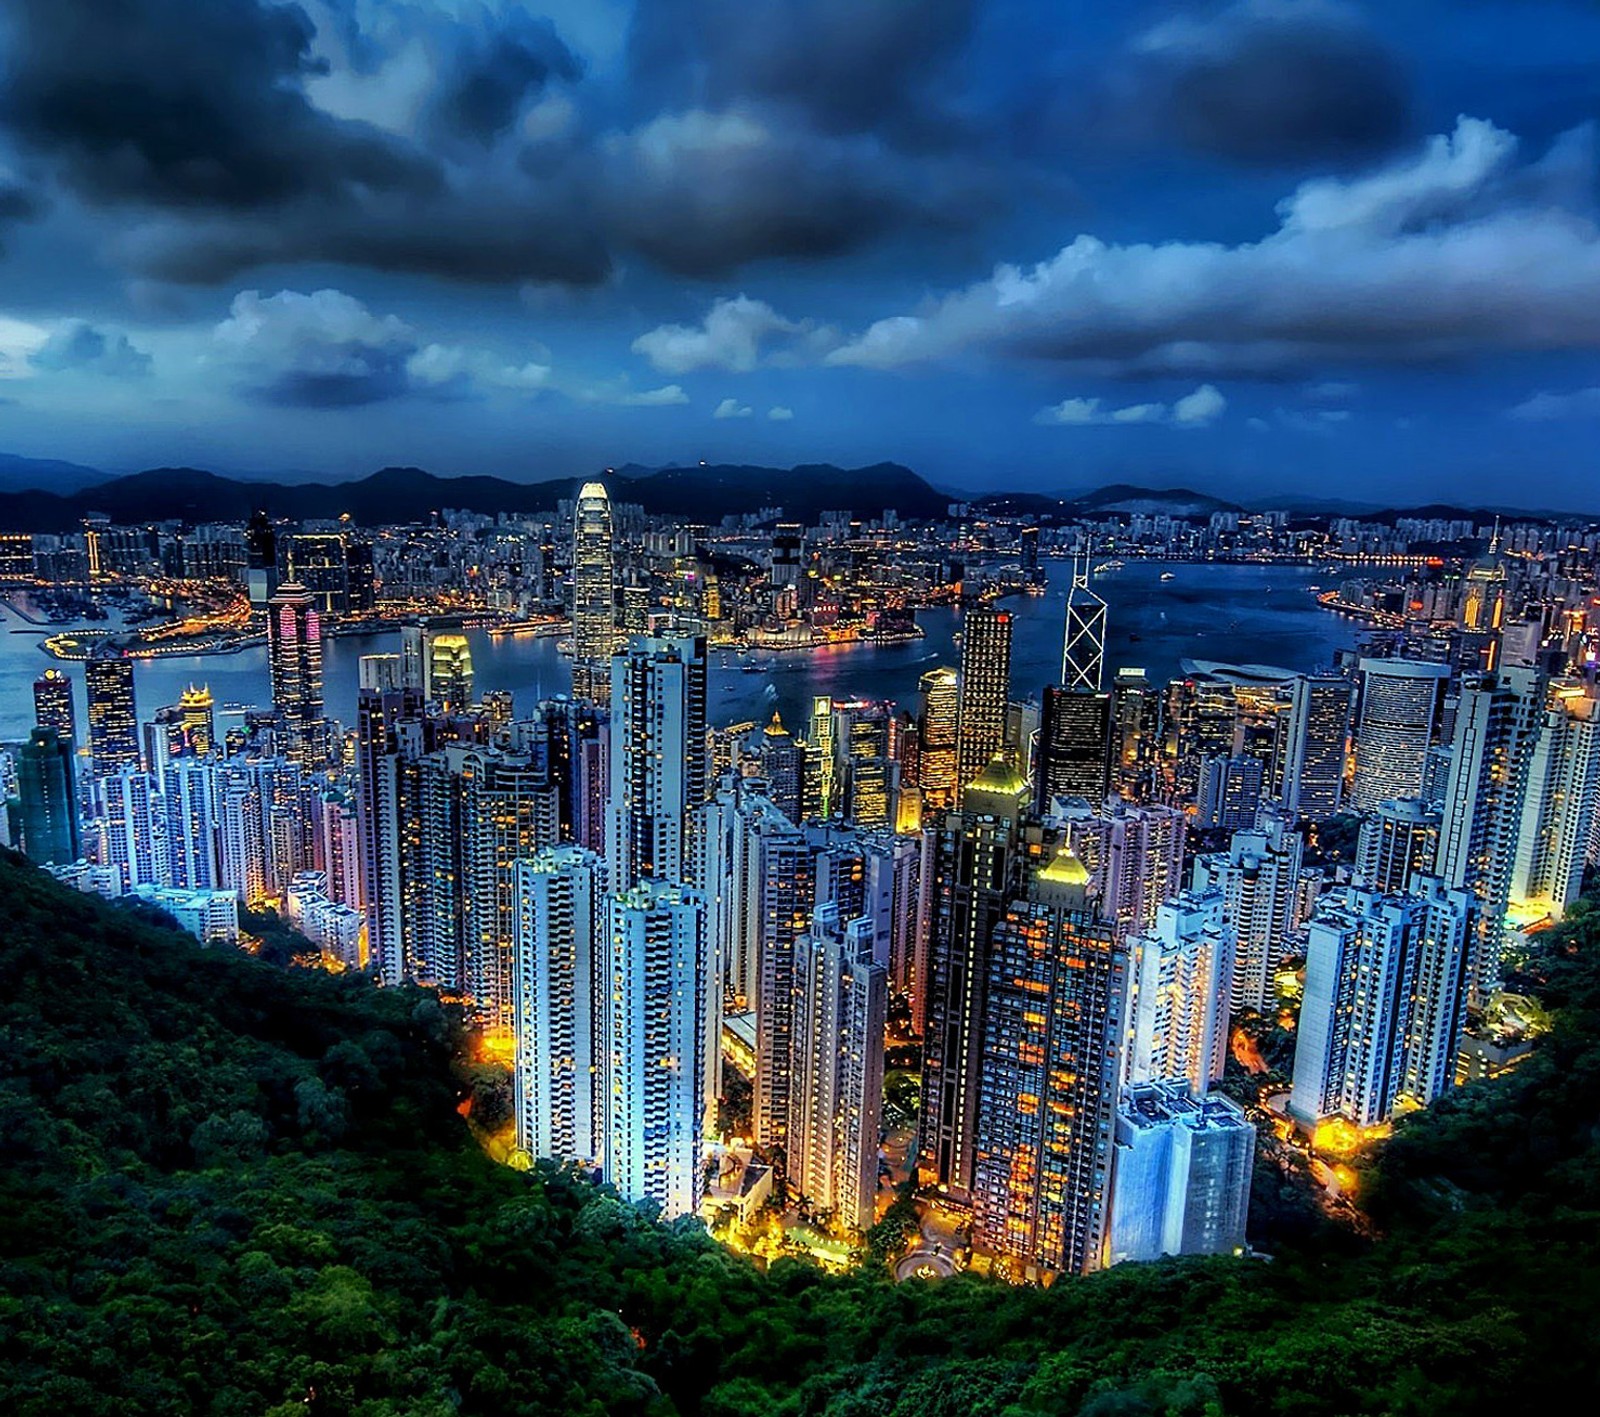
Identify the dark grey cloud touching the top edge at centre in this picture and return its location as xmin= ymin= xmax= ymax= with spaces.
xmin=620 ymin=0 xmax=981 ymax=134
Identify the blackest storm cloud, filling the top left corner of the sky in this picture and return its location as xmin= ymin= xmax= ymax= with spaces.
xmin=0 ymin=0 xmax=438 ymax=208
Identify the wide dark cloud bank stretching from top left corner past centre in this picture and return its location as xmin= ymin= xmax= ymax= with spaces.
xmin=0 ymin=0 xmax=972 ymax=286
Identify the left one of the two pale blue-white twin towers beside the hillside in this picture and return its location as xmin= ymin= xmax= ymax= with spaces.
xmin=512 ymin=846 xmax=608 ymax=1161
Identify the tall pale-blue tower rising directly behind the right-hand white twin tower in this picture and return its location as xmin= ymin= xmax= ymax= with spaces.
xmin=606 ymin=637 xmax=709 ymax=891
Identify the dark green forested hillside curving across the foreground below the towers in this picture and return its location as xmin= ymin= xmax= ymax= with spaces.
xmin=0 ymin=856 xmax=1600 ymax=1417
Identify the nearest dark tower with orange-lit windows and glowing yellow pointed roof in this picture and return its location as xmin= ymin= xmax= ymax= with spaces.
xmin=973 ymin=844 xmax=1128 ymax=1275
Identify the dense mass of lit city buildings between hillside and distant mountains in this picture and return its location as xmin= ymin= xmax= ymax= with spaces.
xmin=3 ymin=483 xmax=1600 ymax=1278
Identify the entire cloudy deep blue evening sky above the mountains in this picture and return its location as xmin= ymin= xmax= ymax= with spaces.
xmin=0 ymin=0 xmax=1600 ymax=510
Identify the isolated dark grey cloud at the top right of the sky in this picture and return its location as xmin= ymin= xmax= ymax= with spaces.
xmin=1125 ymin=0 xmax=1411 ymax=165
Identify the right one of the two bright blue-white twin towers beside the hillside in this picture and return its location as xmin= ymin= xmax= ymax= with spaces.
xmin=602 ymin=881 xmax=710 ymax=1219
